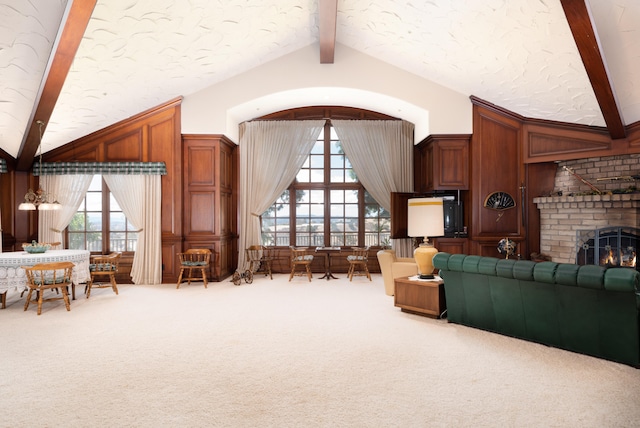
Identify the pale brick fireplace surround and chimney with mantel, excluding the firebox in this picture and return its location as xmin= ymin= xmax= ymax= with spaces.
xmin=533 ymin=155 xmax=640 ymax=264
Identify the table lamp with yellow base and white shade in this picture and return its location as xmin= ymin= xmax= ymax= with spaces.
xmin=407 ymin=198 xmax=444 ymax=279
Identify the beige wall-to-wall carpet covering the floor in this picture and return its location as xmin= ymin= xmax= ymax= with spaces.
xmin=0 ymin=275 xmax=640 ymax=428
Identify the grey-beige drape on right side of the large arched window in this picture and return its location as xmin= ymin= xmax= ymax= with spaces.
xmin=331 ymin=120 xmax=414 ymax=257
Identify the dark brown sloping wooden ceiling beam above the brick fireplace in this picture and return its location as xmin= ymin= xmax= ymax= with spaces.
xmin=560 ymin=0 xmax=626 ymax=140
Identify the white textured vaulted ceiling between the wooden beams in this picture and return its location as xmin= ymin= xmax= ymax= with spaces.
xmin=0 ymin=0 xmax=640 ymax=156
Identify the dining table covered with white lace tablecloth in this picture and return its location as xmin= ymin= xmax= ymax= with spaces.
xmin=0 ymin=250 xmax=91 ymax=309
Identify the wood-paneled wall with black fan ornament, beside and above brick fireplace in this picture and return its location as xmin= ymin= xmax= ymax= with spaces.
xmin=467 ymin=97 xmax=640 ymax=258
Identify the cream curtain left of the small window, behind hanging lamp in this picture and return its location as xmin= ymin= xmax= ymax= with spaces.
xmin=38 ymin=174 xmax=93 ymax=247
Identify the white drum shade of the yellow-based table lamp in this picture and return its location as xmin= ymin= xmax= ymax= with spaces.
xmin=407 ymin=198 xmax=444 ymax=238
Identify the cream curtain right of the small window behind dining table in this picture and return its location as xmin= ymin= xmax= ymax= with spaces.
xmin=102 ymin=174 xmax=162 ymax=284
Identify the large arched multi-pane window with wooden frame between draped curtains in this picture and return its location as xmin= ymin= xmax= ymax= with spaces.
xmin=261 ymin=108 xmax=398 ymax=247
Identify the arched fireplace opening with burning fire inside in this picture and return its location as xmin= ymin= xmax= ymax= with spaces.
xmin=576 ymin=227 xmax=640 ymax=269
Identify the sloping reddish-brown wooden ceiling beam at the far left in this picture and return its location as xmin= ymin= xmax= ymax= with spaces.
xmin=16 ymin=0 xmax=97 ymax=171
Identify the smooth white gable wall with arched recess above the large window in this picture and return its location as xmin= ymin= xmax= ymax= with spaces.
xmin=182 ymin=44 xmax=472 ymax=142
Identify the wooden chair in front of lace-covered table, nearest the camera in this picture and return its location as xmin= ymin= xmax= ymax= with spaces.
xmin=22 ymin=262 xmax=75 ymax=315
